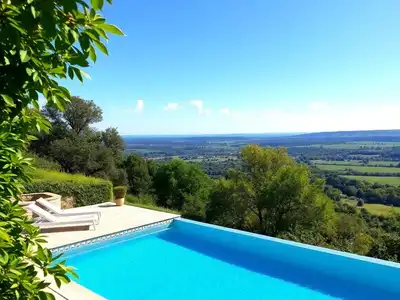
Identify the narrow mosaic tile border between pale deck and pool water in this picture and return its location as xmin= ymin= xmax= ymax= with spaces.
xmin=50 ymin=217 xmax=176 ymax=254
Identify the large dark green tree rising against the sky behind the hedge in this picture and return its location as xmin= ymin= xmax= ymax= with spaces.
xmin=30 ymin=97 xmax=126 ymax=184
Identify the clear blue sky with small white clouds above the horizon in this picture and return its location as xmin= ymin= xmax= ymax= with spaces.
xmin=60 ymin=0 xmax=400 ymax=134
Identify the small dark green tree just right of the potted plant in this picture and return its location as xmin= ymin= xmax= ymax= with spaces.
xmin=122 ymin=154 xmax=151 ymax=195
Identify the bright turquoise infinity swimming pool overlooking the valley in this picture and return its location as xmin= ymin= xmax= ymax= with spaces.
xmin=57 ymin=219 xmax=400 ymax=300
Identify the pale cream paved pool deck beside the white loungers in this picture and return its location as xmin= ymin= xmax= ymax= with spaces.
xmin=41 ymin=202 xmax=179 ymax=300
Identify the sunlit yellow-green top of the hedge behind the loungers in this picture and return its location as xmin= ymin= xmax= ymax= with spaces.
xmin=29 ymin=169 xmax=107 ymax=184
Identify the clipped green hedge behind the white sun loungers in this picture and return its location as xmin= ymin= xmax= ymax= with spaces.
xmin=25 ymin=170 xmax=113 ymax=207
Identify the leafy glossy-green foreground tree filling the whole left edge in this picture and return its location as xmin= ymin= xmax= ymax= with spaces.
xmin=0 ymin=0 xmax=123 ymax=300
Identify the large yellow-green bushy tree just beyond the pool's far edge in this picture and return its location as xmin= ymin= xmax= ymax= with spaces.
xmin=207 ymin=145 xmax=331 ymax=236
